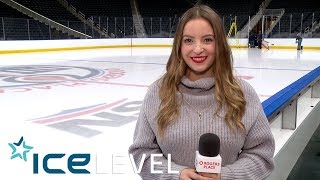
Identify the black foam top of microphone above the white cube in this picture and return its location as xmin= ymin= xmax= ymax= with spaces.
xmin=199 ymin=133 xmax=220 ymax=157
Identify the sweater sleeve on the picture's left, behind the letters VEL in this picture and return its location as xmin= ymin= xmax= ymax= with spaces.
xmin=129 ymin=84 xmax=186 ymax=180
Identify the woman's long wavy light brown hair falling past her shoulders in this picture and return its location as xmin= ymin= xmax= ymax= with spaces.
xmin=157 ymin=4 xmax=246 ymax=137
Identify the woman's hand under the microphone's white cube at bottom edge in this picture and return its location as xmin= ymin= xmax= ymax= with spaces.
xmin=180 ymin=168 xmax=220 ymax=180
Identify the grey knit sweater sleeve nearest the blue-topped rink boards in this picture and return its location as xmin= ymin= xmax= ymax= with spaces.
xmin=221 ymin=82 xmax=275 ymax=180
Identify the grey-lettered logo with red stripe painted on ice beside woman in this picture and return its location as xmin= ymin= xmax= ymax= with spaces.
xmin=32 ymin=98 xmax=142 ymax=138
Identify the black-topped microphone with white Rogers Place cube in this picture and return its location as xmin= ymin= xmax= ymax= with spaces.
xmin=195 ymin=133 xmax=221 ymax=173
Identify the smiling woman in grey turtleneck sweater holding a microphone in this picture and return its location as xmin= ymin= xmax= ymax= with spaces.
xmin=129 ymin=5 xmax=275 ymax=180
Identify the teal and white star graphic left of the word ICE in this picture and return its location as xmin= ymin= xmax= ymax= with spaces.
xmin=8 ymin=136 xmax=33 ymax=161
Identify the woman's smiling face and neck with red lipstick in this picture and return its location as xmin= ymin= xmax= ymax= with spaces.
xmin=181 ymin=18 xmax=215 ymax=81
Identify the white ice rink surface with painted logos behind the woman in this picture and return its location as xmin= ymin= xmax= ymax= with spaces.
xmin=0 ymin=48 xmax=320 ymax=180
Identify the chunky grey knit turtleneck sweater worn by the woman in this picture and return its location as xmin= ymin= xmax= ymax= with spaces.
xmin=129 ymin=77 xmax=275 ymax=180
